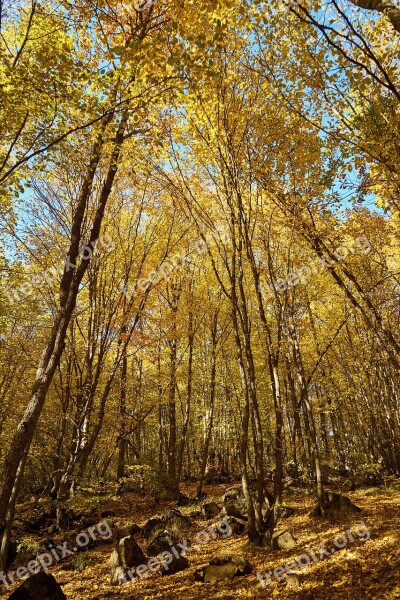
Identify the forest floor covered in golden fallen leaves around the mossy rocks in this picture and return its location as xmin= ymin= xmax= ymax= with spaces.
xmin=0 ymin=485 xmax=400 ymax=600
